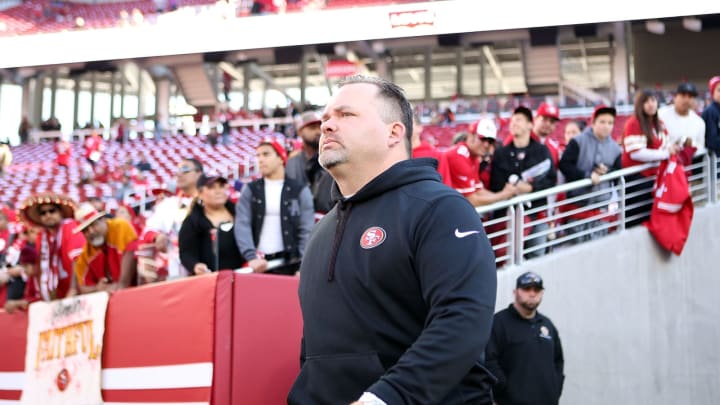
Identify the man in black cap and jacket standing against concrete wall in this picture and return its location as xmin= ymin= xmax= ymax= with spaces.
xmin=485 ymin=272 xmax=565 ymax=405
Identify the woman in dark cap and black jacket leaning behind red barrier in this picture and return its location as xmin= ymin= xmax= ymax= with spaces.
xmin=178 ymin=175 xmax=245 ymax=275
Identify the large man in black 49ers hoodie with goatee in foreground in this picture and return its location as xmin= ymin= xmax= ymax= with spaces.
xmin=288 ymin=76 xmax=497 ymax=405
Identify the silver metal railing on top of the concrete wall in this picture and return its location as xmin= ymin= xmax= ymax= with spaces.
xmin=476 ymin=153 xmax=720 ymax=265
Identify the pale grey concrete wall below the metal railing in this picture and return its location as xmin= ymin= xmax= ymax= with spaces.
xmin=497 ymin=205 xmax=720 ymax=405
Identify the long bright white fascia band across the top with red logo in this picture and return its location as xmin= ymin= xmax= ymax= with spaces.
xmin=0 ymin=0 xmax=720 ymax=68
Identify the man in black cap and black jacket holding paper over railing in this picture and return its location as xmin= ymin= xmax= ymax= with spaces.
xmin=490 ymin=106 xmax=557 ymax=257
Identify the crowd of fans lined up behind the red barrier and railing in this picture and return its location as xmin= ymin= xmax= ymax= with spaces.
xmin=0 ymin=76 xmax=720 ymax=312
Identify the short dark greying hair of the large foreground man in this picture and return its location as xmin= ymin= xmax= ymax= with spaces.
xmin=338 ymin=75 xmax=413 ymax=157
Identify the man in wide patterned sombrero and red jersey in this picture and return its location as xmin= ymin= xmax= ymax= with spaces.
xmin=14 ymin=193 xmax=85 ymax=306
